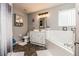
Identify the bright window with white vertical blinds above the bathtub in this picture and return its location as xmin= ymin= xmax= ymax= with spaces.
xmin=58 ymin=9 xmax=76 ymax=26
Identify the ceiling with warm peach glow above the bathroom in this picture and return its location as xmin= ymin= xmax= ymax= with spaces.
xmin=13 ymin=3 xmax=61 ymax=13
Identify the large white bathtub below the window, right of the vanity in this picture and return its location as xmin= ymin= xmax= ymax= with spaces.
xmin=46 ymin=30 xmax=74 ymax=54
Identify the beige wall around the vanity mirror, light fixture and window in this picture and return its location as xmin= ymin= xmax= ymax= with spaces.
xmin=28 ymin=3 xmax=75 ymax=30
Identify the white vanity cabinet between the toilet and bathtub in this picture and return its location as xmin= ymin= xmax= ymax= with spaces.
xmin=30 ymin=31 xmax=45 ymax=45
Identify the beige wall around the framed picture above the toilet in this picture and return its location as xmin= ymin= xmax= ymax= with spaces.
xmin=13 ymin=8 xmax=28 ymax=41
